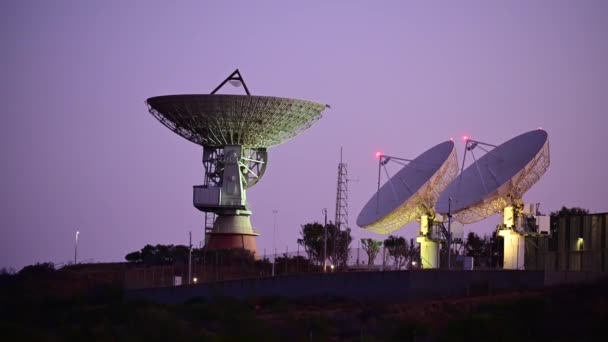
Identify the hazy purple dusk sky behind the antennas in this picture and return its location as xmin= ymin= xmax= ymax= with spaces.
xmin=0 ymin=0 xmax=608 ymax=268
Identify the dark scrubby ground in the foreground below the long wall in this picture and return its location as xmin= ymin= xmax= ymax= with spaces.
xmin=0 ymin=271 xmax=608 ymax=342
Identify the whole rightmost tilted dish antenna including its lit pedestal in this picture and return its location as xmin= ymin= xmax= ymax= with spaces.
xmin=436 ymin=129 xmax=550 ymax=270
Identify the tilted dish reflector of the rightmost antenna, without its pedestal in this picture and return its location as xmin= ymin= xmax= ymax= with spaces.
xmin=436 ymin=129 xmax=550 ymax=224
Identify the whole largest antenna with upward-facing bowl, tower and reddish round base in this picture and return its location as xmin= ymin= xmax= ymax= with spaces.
xmin=146 ymin=69 xmax=328 ymax=253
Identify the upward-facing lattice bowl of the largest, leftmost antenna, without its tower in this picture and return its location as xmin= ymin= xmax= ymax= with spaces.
xmin=146 ymin=94 xmax=326 ymax=148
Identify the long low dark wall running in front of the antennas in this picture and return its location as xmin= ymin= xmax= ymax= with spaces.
xmin=126 ymin=270 xmax=560 ymax=304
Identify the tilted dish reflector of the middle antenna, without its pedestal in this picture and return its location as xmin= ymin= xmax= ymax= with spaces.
xmin=357 ymin=141 xmax=458 ymax=234
